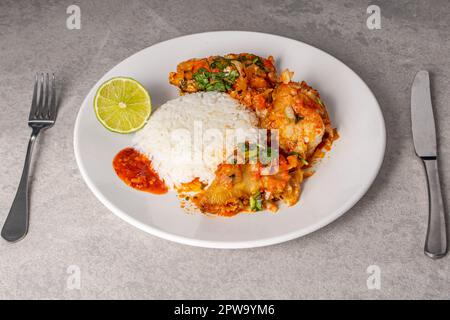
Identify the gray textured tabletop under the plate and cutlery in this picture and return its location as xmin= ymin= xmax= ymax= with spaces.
xmin=0 ymin=0 xmax=450 ymax=299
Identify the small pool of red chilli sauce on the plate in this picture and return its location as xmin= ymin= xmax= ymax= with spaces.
xmin=113 ymin=148 xmax=167 ymax=194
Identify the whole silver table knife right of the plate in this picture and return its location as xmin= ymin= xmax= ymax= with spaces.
xmin=411 ymin=70 xmax=447 ymax=259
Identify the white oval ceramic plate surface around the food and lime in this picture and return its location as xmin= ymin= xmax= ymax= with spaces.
xmin=74 ymin=31 xmax=386 ymax=248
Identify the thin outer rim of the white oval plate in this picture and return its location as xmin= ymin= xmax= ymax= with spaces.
xmin=73 ymin=30 xmax=386 ymax=249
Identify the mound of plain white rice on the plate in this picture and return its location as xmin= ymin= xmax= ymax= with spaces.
xmin=133 ymin=92 xmax=258 ymax=188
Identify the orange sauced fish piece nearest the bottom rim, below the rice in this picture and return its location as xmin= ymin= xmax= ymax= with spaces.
xmin=192 ymin=149 xmax=303 ymax=216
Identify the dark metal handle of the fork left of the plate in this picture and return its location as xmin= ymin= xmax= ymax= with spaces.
xmin=1 ymin=128 xmax=40 ymax=242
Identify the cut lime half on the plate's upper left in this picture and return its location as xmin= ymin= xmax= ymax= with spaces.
xmin=94 ymin=77 xmax=152 ymax=133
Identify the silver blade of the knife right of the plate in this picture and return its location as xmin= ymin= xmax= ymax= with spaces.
xmin=411 ymin=70 xmax=437 ymax=158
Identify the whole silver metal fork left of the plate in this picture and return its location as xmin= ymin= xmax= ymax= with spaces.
xmin=1 ymin=73 xmax=56 ymax=242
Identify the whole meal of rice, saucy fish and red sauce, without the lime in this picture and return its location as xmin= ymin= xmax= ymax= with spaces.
xmin=109 ymin=53 xmax=338 ymax=216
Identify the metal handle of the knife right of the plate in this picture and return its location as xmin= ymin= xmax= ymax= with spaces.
xmin=422 ymin=158 xmax=447 ymax=259
